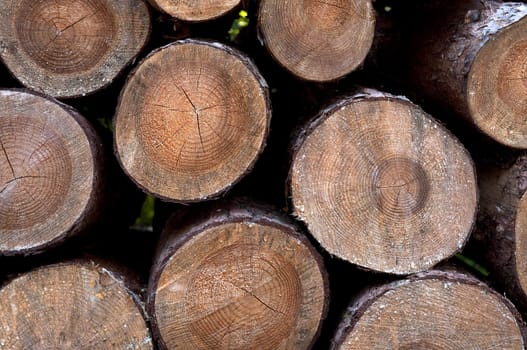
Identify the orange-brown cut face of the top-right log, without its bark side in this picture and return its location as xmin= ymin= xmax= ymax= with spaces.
xmin=466 ymin=13 xmax=527 ymax=148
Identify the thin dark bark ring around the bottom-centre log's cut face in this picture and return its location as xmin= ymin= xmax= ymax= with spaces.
xmin=146 ymin=198 xmax=330 ymax=349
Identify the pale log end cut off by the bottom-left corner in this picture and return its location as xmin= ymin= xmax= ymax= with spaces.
xmin=0 ymin=263 xmax=153 ymax=349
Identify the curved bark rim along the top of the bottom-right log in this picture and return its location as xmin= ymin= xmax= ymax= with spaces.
xmin=330 ymin=270 xmax=527 ymax=350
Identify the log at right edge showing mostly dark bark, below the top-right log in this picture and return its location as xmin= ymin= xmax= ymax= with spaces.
xmin=474 ymin=153 xmax=527 ymax=311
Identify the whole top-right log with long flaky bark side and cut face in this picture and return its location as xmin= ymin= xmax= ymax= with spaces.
xmin=407 ymin=0 xmax=527 ymax=149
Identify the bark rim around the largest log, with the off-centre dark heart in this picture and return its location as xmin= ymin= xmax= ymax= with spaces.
xmin=285 ymin=88 xmax=480 ymax=275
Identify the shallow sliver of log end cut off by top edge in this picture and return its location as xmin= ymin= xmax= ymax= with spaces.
xmin=149 ymin=0 xmax=240 ymax=21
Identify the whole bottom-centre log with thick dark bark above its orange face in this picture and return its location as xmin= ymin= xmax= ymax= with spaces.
xmin=148 ymin=202 xmax=328 ymax=349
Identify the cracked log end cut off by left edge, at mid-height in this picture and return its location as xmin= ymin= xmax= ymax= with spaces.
xmin=0 ymin=90 xmax=102 ymax=255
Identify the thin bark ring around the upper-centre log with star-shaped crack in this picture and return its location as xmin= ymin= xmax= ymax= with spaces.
xmin=113 ymin=39 xmax=272 ymax=204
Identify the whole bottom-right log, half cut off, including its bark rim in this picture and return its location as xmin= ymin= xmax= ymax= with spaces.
xmin=330 ymin=271 xmax=525 ymax=350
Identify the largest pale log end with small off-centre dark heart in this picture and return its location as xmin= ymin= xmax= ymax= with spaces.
xmin=290 ymin=93 xmax=477 ymax=274
